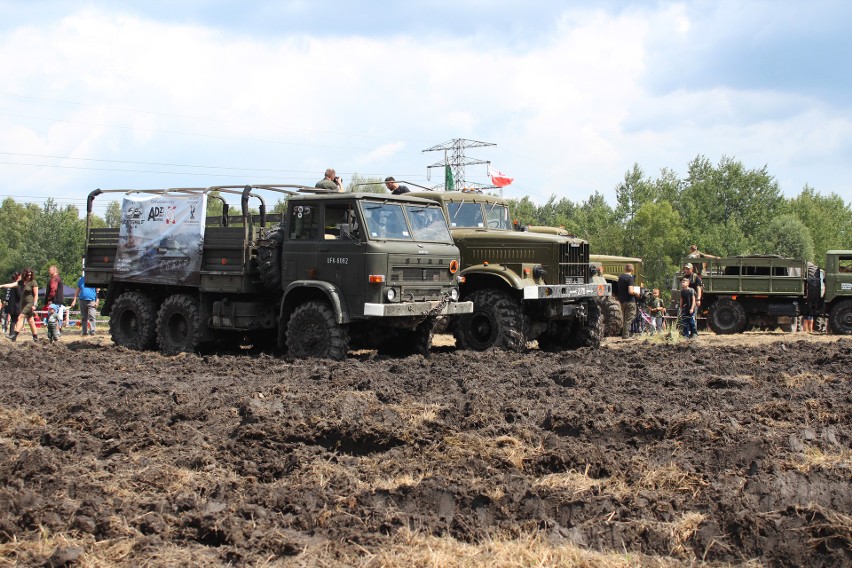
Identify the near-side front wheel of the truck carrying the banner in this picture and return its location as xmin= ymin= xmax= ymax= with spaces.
xmin=286 ymin=302 xmax=349 ymax=361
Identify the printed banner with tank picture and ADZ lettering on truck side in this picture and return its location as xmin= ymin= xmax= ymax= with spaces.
xmin=113 ymin=194 xmax=207 ymax=286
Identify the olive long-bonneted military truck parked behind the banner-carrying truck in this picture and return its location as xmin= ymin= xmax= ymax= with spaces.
xmin=409 ymin=192 xmax=611 ymax=351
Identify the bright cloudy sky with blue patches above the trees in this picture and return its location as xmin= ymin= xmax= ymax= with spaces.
xmin=0 ymin=0 xmax=852 ymax=217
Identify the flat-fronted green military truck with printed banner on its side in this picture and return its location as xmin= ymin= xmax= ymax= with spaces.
xmin=85 ymin=185 xmax=473 ymax=359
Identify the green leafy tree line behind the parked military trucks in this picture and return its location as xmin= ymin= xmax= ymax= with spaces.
xmin=0 ymin=156 xmax=852 ymax=289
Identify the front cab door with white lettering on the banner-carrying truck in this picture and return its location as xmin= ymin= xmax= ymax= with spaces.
xmin=317 ymin=201 xmax=369 ymax=315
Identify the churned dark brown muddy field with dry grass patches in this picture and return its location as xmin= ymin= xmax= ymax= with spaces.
xmin=0 ymin=334 xmax=852 ymax=566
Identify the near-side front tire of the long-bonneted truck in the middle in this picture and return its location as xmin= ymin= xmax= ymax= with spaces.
xmin=455 ymin=289 xmax=527 ymax=352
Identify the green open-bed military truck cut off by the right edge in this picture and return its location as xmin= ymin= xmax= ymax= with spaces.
xmin=673 ymin=250 xmax=852 ymax=335
